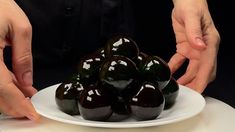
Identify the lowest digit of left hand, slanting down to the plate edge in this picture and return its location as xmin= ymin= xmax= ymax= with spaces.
xmin=0 ymin=61 xmax=39 ymax=121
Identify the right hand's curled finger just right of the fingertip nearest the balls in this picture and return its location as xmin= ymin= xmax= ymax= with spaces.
xmin=177 ymin=60 xmax=198 ymax=85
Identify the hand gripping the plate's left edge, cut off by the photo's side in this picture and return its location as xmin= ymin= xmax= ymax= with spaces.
xmin=0 ymin=0 xmax=39 ymax=121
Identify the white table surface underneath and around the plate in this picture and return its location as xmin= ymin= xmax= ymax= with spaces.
xmin=0 ymin=97 xmax=235 ymax=132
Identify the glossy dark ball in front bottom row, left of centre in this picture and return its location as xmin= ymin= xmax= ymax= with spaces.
xmin=78 ymin=84 xmax=112 ymax=121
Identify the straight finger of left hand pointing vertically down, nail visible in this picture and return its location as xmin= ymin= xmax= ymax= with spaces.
xmin=12 ymin=21 xmax=35 ymax=96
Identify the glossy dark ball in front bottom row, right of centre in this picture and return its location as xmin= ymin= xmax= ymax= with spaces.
xmin=130 ymin=82 xmax=165 ymax=120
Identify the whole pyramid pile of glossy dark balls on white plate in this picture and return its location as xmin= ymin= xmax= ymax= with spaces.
xmin=55 ymin=35 xmax=179 ymax=121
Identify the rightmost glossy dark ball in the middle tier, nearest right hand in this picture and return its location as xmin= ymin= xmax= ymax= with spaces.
xmin=140 ymin=56 xmax=171 ymax=89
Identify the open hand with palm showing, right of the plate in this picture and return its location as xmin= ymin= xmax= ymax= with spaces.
xmin=169 ymin=0 xmax=220 ymax=93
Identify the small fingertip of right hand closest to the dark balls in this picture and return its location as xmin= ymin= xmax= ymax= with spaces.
xmin=168 ymin=53 xmax=186 ymax=74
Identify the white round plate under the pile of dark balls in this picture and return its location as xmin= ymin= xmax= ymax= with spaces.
xmin=31 ymin=84 xmax=205 ymax=128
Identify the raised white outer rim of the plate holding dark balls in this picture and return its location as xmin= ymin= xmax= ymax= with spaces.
xmin=31 ymin=83 xmax=206 ymax=128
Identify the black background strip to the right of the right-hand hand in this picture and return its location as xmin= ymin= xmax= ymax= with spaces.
xmin=205 ymin=0 xmax=235 ymax=107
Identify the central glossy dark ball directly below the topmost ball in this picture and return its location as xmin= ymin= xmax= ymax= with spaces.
xmin=100 ymin=56 xmax=137 ymax=93
